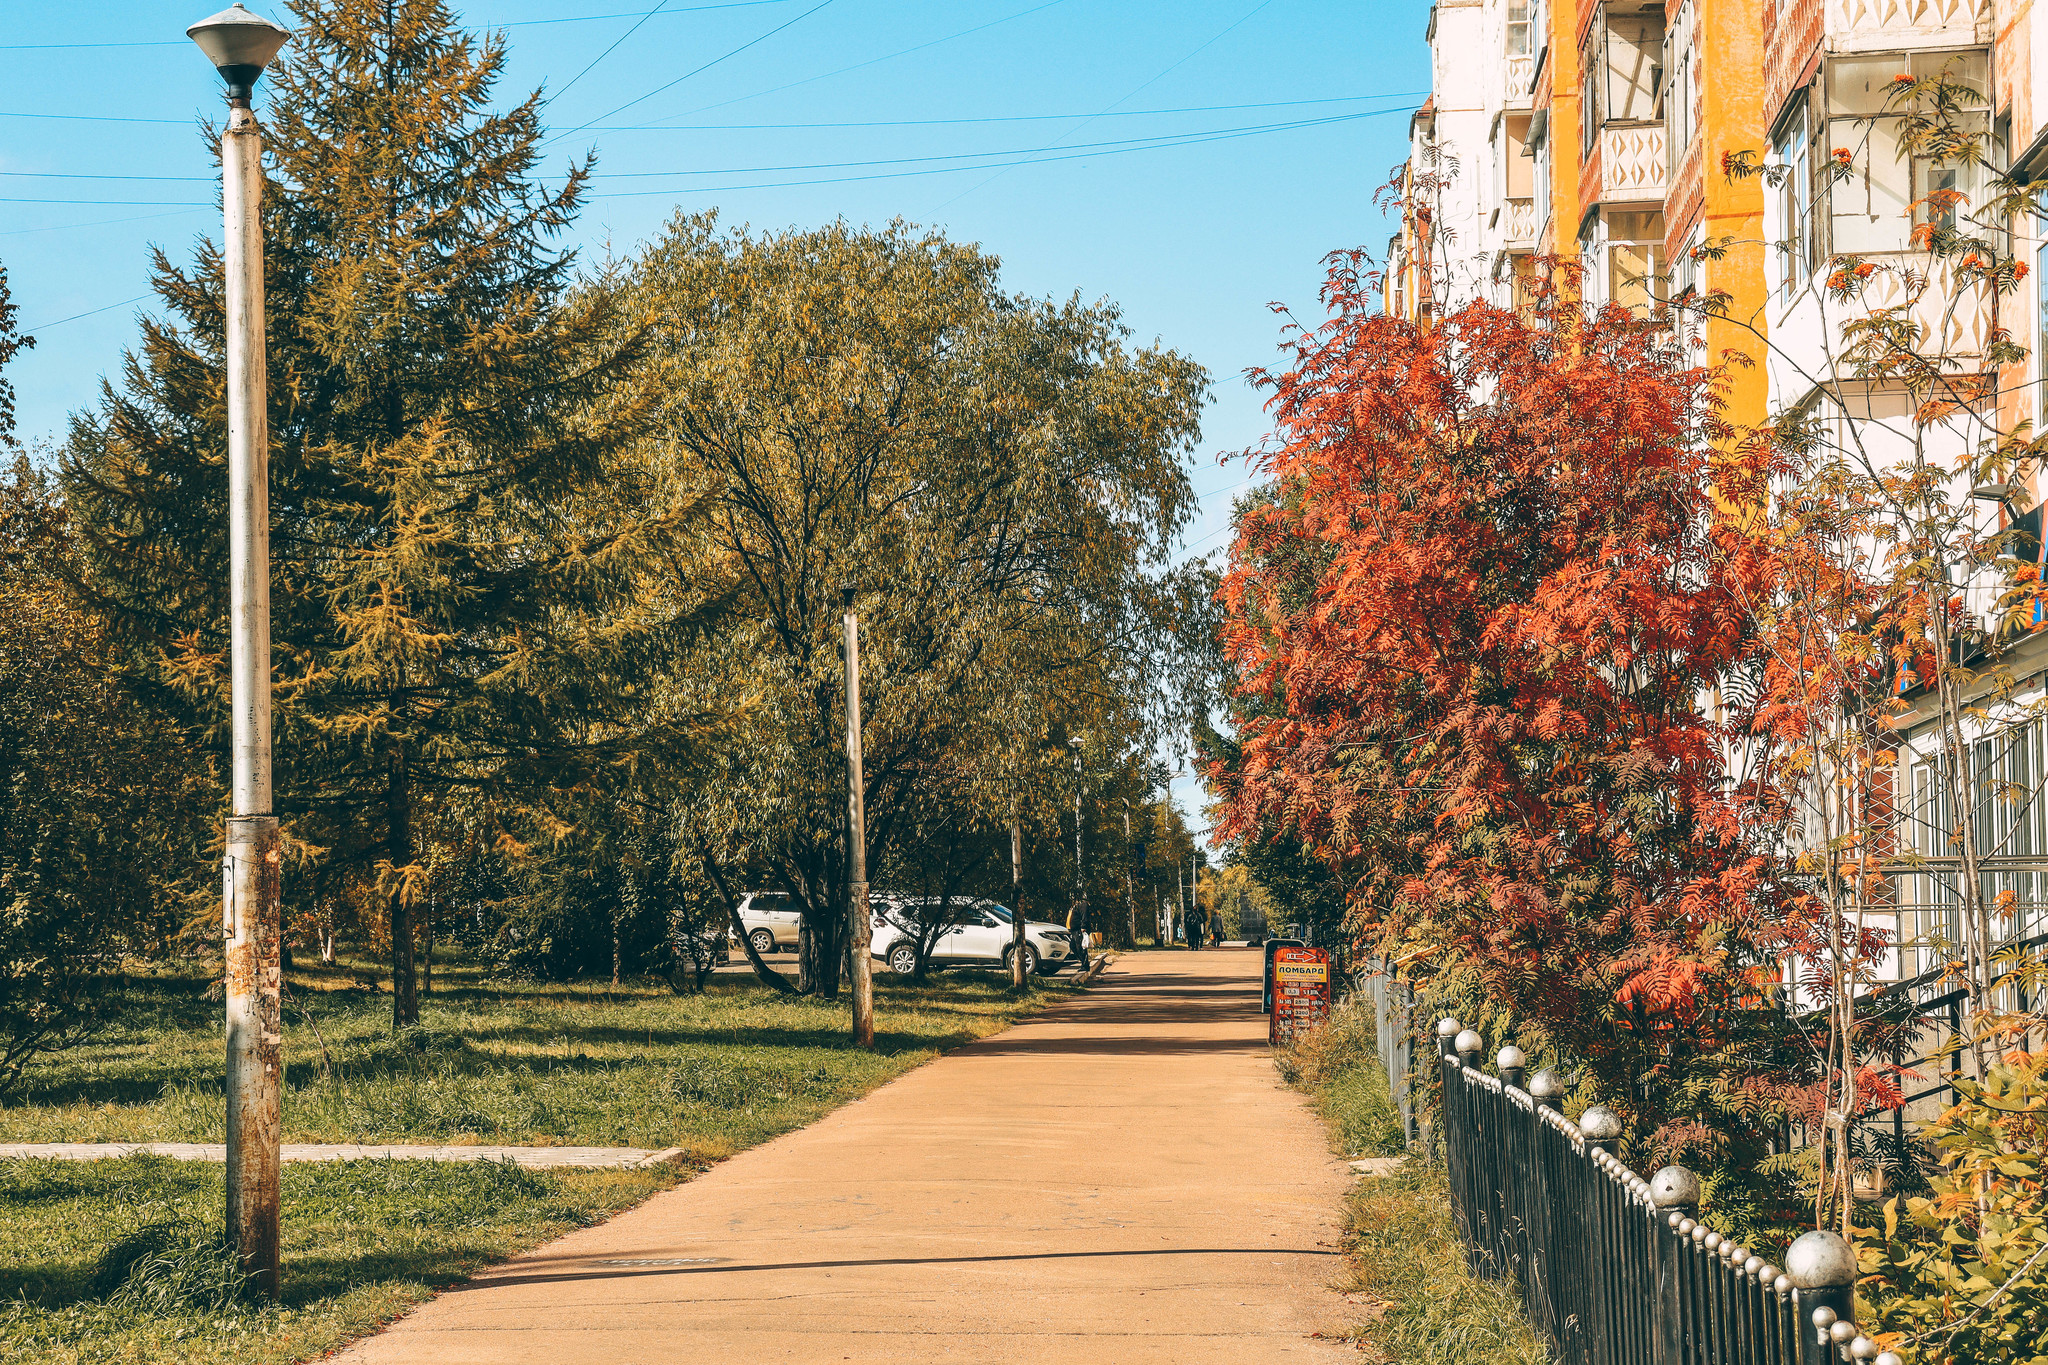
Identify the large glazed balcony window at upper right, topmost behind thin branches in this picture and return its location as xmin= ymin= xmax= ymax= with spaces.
xmin=1827 ymin=51 xmax=1995 ymax=256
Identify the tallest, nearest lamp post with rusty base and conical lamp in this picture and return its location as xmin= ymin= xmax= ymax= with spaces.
xmin=184 ymin=4 xmax=287 ymax=1297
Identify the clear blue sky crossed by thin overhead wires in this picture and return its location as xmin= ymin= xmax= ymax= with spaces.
xmin=0 ymin=0 xmax=1427 ymax=826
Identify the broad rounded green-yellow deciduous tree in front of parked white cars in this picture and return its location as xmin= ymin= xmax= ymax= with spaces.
xmin=631 ymin=217 xmax=1206 ymax=993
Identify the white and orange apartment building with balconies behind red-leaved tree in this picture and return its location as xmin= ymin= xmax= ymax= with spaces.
xmin=1386 ymin=0 xmax=2048 ymax=994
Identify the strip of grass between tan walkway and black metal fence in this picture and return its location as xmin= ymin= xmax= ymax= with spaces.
xmin=1274 ymin=997 xmax=1548 ymax=1365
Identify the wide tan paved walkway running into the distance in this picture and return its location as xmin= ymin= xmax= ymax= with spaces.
xmin=340 ymin=952 xmax=1356 ymax=1365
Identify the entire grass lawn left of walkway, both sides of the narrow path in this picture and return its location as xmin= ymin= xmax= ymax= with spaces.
xmin=0 ymin=968 xmax=1077 ymax=1365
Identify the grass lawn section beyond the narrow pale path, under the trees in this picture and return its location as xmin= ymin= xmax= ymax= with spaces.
xmin=0 ymin=968 xmax=1073 ymax=1160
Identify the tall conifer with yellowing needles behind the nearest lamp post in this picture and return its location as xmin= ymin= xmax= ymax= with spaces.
xmin=63 ymin=0 xmax=682 ymax=1023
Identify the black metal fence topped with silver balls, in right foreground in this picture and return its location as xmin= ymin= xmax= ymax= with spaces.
xmin=1438 ymin=1019 xmax=1901 ymax=1365
